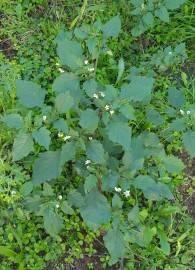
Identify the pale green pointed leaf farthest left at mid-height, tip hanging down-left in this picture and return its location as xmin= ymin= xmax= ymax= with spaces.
xmin=12 ymin=133 xmax=34 ymax=161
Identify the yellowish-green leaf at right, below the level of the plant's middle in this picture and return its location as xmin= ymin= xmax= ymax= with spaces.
xmin=164 ymin=156 xmax=185 ymax=173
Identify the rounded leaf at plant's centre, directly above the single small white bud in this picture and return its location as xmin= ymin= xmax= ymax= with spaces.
xmin=79 ymin=109 xmax=99 ymax=133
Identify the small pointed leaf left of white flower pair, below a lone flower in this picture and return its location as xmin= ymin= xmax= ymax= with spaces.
xmin=32 ymin=127 xmax=51 ymax=150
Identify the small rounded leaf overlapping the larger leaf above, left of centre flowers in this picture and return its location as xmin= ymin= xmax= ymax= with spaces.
xmin=55 ymin=92 xmax=74 ymax=113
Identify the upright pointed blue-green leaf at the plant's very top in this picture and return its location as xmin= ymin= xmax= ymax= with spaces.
xmin=102 ymin=15 xmax=121 ymax=38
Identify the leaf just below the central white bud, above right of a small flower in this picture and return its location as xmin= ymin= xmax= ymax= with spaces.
xmin=87 ymin=140 xmax=105 ymax=164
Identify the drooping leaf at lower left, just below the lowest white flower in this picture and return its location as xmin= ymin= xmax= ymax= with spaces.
xmin=43 ymin=208 xmax=63 ymax=237
